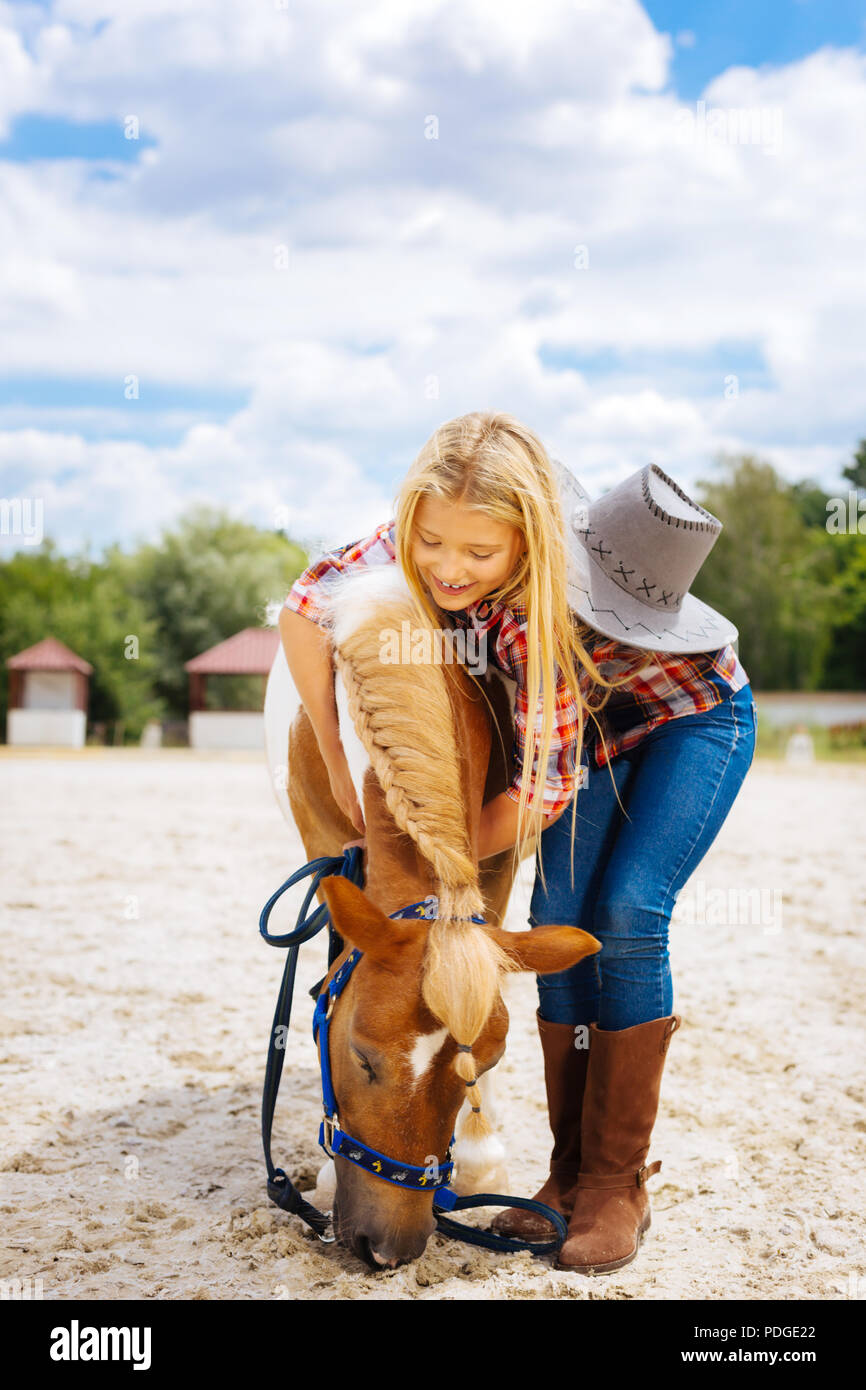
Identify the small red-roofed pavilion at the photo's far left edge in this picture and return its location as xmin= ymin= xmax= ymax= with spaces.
xmin=6 ymin=637 xmax=93 ymax=748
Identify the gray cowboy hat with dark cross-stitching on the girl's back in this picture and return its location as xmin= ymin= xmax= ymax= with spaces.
xmin=550 ymin=459 xmax=737 ymax=653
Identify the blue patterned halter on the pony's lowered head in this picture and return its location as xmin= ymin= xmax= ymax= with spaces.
xmin=313 ymin=894 xmax=484 ymax=1205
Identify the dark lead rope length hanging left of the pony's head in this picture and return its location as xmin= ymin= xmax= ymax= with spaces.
xmin=259 ymin=845 xmax=364 ymax=1243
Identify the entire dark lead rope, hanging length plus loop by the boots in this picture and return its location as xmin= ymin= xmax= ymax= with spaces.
xmin=259 ymin=845 xmax=569 ymax=1255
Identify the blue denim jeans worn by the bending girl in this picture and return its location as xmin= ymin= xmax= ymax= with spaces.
xmin=530 ymin=685 xmax=756 ymax=1030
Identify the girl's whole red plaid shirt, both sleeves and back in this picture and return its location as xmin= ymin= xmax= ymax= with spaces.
xmin=284 ymin=521 xmax=748 ymax=816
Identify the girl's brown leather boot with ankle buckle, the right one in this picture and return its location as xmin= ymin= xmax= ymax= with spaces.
xmin=556 ymin=1013 xmax=683 ymax=1275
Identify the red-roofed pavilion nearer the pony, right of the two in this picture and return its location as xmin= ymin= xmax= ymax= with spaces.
xmin=183 ymin=627 xmax=279 ymax=749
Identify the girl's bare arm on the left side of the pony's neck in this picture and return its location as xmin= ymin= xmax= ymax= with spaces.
xmin=278 ymin=607 xmax=366 ymax=835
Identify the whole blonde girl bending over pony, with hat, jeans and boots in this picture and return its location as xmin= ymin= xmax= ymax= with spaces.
xmin=279 ymin=413 xmax=755 ymax=1272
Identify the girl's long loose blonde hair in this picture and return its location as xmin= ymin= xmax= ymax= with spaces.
xmin=395 ymin=411 xmax=617 ymax=891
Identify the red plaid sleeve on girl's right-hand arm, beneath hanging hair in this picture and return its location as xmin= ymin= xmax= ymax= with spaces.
xmin=496 ymin=607 xmax=577 ymax=816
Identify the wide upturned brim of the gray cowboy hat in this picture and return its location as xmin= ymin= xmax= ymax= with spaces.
xmin=567 ymin=538 xmax=738 ymax=655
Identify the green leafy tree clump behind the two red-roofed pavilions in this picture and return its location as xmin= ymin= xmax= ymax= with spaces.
xmin=0 ymin=507 xmax=307 ymax=739
